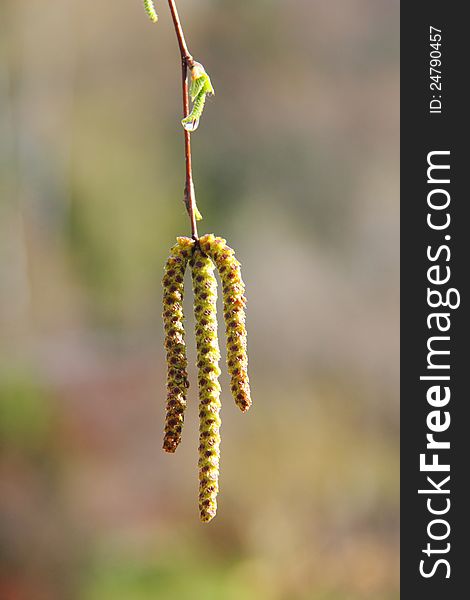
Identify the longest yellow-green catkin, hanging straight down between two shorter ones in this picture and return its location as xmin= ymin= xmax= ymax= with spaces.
xmin=191 ymin=249 xmax=220 ymax=522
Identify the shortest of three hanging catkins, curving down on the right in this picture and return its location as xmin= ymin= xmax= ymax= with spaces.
xmin=199 ymin=234 xmax=251 ymax=412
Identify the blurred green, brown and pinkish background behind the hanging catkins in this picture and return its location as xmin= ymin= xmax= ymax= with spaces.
xmin=0 ymin=0 xmax=399 ymax=600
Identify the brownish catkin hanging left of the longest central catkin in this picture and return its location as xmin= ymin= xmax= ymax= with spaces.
xmin=163 ymin=237 xmax=194 ymax=452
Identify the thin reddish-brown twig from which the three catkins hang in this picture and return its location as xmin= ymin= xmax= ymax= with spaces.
xmin=168 ymin=0 xmax=198 ymax=240
